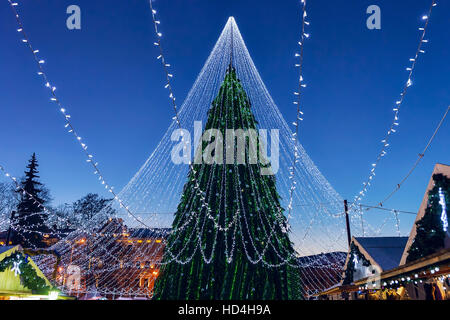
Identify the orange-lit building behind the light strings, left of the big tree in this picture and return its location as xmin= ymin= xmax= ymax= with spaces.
xmin=51 ymin=219 xmax=170 ymax=299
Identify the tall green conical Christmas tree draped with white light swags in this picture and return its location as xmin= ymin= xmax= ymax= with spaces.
xmin=154 ymin=64 xmax=302 ymax=300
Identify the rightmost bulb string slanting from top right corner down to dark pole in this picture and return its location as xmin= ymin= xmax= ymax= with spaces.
xmin=352 ymin=0 xmax=437 ymax=205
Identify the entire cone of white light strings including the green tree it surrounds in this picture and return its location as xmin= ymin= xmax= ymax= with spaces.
xmin=37 ymin=18 xmax=367 ymax=299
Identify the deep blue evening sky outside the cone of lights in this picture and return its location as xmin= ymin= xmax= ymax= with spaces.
xmin=0 ymin=0 xmax=450 ymax=233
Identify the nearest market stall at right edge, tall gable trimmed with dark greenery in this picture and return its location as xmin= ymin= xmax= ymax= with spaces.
xmin=355 ymin=163 xmax=450 ymax=300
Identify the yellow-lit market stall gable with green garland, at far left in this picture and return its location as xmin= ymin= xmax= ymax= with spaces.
xmin=0 ymin=245 xmax=61 ymax=300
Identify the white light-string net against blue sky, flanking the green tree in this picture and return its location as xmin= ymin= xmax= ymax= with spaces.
xmin=110 ymin=18 xmax=360 ymax=255
